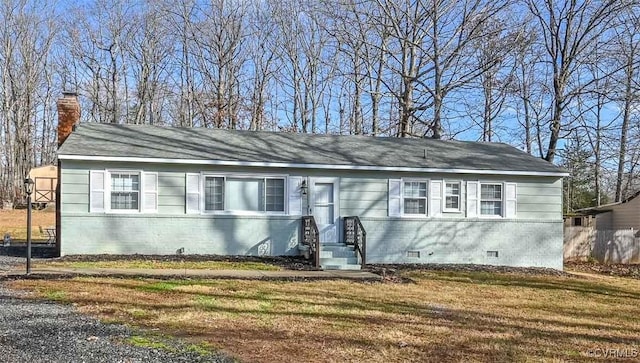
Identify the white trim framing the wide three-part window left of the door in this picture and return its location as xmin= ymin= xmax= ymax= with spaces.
xmin=200 ymin=171 xmax=289 ymax=216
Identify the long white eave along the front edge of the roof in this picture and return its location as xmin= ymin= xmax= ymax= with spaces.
xmin=58 ymin=154 xmax=569 ymax=177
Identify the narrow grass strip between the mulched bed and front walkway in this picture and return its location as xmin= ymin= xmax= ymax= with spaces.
xmin=35 ymin=259 xmax=281 ymax=271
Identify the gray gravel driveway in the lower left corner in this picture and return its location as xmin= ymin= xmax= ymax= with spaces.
xmin=0 ymin=256 xmax=230 ymax=363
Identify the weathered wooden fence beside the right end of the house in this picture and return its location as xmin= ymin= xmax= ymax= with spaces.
xmin=564 ymin=227 xmax=640 ymax=263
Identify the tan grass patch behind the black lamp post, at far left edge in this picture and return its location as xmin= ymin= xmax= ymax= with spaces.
xmin=0 ymin=209 xmax=56 ymax=240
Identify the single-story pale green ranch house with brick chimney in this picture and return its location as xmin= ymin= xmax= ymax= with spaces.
xmin=58 ymin=94 xmax=566 ymax=269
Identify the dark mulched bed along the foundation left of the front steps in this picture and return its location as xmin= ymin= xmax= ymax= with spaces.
xmin=52 ymin=254 xmax=316 ymax=271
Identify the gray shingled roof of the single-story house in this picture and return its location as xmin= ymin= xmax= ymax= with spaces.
xmin=58 ymin=123 xmax=564 ymax=173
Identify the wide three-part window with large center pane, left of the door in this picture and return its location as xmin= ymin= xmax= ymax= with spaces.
xmin=204 ymin=176 xmax=285 ymax=212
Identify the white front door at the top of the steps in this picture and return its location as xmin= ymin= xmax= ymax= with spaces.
xmin=309 ymin=178 xmax=340 ymax=243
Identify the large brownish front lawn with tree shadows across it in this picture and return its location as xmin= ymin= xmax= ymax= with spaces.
xmin=8 ymin=272 xmax=640 ymax=362
